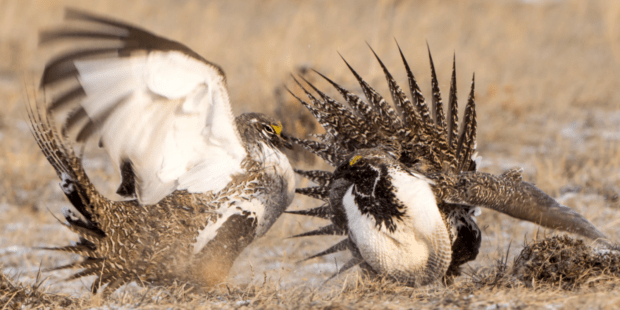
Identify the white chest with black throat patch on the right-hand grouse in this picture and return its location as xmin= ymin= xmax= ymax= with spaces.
xmin=336 ymin=155 xmax=452 ymax=284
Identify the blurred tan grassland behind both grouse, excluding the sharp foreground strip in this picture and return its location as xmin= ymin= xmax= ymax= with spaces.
xmin=0 ymin=0 xmax=620 ymax=298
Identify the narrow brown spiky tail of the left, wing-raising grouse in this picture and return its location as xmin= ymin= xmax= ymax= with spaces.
xmin=26 ymin=95 xmax=118 ymax=293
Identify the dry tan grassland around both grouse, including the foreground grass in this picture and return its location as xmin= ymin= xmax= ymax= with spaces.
xmin=0 ymin=0 xmax=620 ymax=309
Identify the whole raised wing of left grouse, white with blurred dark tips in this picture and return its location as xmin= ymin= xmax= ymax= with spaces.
xmin=40 ymin=10 xmax=246 ymax=204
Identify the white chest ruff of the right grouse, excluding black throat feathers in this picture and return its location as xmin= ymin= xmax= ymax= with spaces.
xmin=343 ymin=171 xmax=445 ymax=277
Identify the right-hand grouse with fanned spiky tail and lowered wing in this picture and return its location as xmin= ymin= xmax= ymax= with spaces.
xmin=289 ymin=44 xmax=605 ymax=285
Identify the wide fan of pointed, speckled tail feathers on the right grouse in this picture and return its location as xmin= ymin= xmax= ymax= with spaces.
xmin=289 ymin=44 xmax=477 ymax=284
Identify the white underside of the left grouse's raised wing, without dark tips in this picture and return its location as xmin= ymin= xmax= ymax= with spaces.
xmin=75 ymin=51 xmax=247 ymax=204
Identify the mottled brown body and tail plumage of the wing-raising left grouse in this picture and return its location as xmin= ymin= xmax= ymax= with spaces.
xmin=28 ymin=100 xmax=296 ymax=293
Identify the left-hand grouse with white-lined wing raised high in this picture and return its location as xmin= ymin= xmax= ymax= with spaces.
xmin=30 ymin=10 xmax=295 ymax=292
